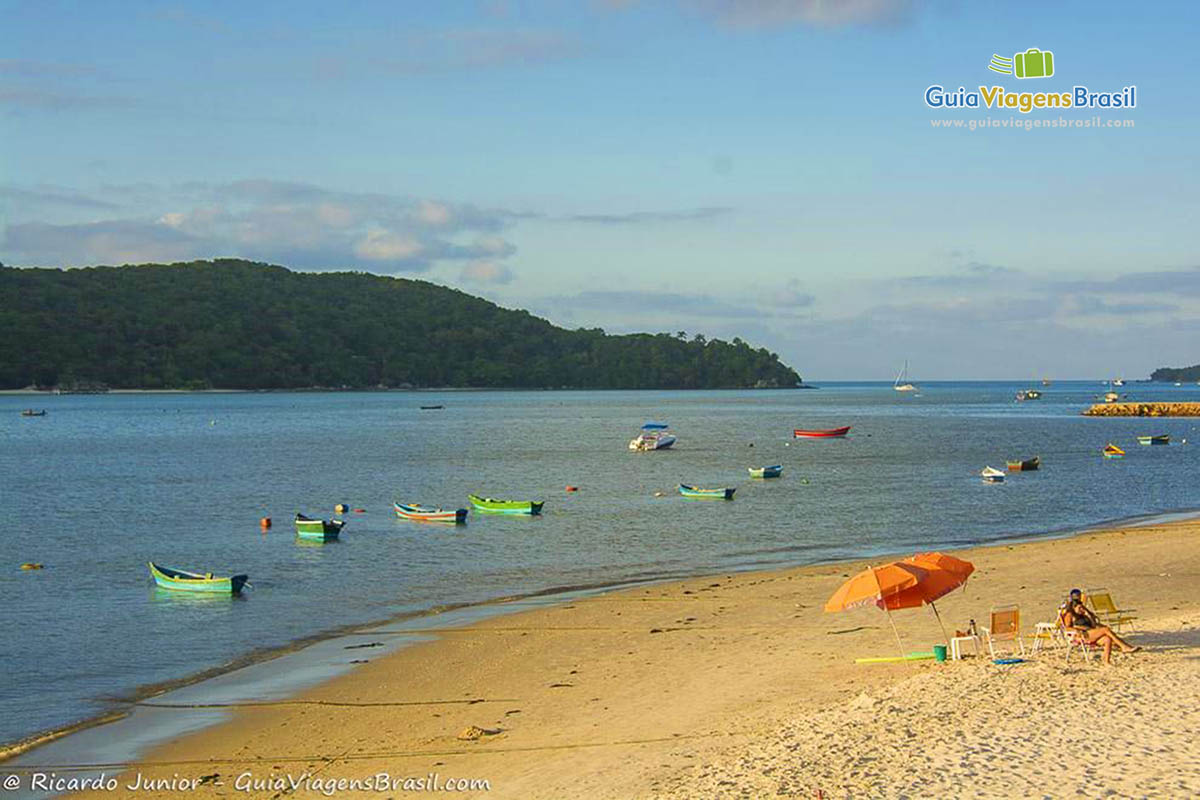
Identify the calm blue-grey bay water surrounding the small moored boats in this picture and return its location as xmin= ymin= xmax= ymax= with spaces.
xmin=0 ymin=383 xmax=1200 ymax=741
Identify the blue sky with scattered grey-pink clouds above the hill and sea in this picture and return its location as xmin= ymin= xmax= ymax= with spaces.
xmin=0 ymin=0 xmax=1200 ymax=381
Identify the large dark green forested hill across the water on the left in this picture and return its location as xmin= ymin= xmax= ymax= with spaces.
xmin=0 ymin=260 xmax=799 ymax=389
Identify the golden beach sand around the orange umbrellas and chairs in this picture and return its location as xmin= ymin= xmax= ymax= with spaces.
xmin=54 ymin=522 xmax=1200 ymax=799
